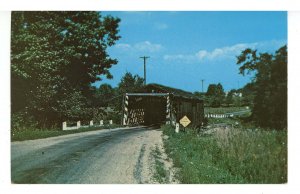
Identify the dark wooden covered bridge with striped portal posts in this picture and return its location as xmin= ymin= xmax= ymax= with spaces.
xmin=122 ymin=84 xmax=204 ymax=127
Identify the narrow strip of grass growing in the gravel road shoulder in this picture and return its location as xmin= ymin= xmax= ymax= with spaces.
xmin=151 ymin=147 xmax=167 ymax=183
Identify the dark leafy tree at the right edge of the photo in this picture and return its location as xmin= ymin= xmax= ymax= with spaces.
xmin=237 ymin=46 xmax=287 ymax=129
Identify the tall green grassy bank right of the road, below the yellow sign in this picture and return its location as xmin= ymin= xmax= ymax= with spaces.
xmin=163 ymin=126 xmax=287 ymax=183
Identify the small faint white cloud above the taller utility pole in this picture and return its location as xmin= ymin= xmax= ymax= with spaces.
xmin=115 ymin=41 xmax=163 ymax=53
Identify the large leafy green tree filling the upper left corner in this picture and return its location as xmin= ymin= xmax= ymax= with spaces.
xmin=11 ymin=11 xmax=120 ymax=128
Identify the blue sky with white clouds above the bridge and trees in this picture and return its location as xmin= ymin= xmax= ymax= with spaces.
xmin=96 ymin=11 xmax=287 ymax=92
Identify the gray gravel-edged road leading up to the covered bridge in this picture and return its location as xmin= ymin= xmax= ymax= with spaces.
xmin=11 ymin=127 xmax=166 ymax=184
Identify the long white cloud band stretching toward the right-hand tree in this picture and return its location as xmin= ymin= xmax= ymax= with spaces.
xmin=164 ymin=40 xmax=286 ymax=62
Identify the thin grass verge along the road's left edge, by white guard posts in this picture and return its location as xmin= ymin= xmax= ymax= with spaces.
xmin=11 ymin=124 xmax=120 ymax=141
